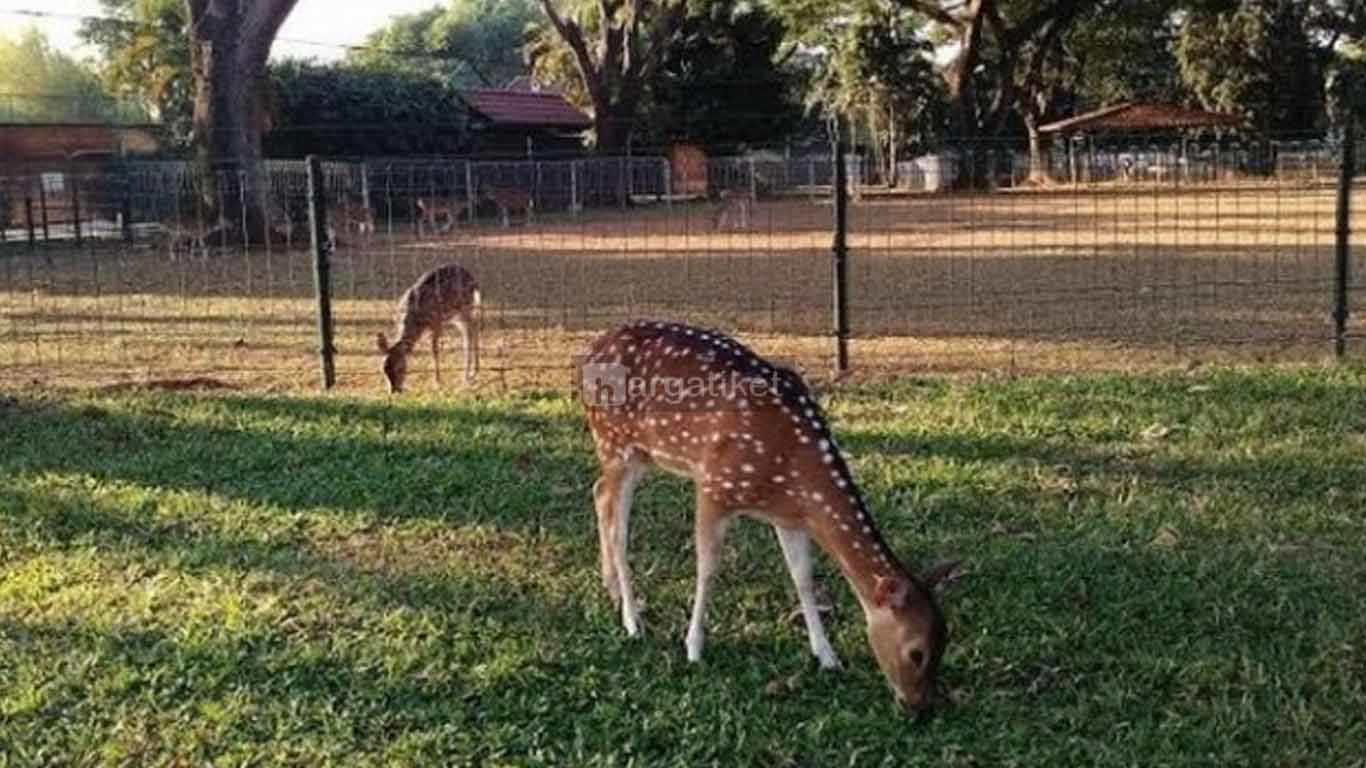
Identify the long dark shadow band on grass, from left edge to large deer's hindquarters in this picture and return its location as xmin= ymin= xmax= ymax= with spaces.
xmin=0 ymin=388 xmax=596 ymax=533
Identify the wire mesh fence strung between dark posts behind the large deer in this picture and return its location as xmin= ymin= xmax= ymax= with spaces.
xmin=0 ymin=133 xmax=1366 ymax=391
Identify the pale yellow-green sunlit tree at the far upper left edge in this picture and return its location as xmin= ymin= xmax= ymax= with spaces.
xmin=0 ymin=27 xmax=138 ymax=123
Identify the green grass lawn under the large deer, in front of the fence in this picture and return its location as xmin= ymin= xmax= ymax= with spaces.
xmin=0 ymin=369 xmax=1366 ymax=767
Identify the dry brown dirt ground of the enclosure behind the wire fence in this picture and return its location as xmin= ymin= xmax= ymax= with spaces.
xmin=0 ymin=186 xmax=1366 ymax=392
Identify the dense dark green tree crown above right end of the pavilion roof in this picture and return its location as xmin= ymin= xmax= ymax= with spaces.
xmin=1176 ymin=0 xmax=1325 ymax=137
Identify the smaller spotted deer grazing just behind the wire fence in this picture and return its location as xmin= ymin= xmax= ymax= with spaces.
xmin=376 ymin=264 xmax=479 ymax=392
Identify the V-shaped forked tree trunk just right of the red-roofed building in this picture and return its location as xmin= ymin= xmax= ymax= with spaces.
xmin=530 ymin=0 xmax=687 ymax=153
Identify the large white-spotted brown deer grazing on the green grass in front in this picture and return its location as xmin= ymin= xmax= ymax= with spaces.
xmin=579 ymin=321 xmax=959 ymax=713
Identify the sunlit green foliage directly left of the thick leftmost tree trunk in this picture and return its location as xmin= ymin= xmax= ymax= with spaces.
xmin=79 ymin=0 xmax=194 ymax=137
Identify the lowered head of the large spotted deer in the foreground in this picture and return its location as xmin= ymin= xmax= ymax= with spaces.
xmin=865 ymin=562 xmax=960 ymax=716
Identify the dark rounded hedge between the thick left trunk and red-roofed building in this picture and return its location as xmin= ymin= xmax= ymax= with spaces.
xmin=265 ymin=60 xmax=467 ymax=157
